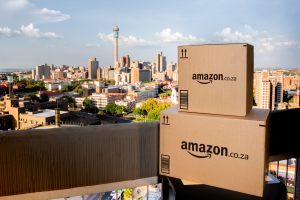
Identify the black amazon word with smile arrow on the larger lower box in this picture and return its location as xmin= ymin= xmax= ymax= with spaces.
xmin=181 ymin=141 xmax=228 ymax=158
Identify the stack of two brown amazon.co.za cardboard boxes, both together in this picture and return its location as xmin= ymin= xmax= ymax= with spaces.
xmin=160 ymin=44 xmax=270 ymax=196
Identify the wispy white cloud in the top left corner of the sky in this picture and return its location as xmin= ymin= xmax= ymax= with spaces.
xmin=0 ymin=0 xmax=70 ymax=24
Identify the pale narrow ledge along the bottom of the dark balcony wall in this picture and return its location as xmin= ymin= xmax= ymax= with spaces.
xmin=0 ymin=176 xmax=158 ymax=200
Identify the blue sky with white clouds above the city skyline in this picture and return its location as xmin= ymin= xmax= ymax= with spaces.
xmin=0 ymin=0 xmax=300 ymax=68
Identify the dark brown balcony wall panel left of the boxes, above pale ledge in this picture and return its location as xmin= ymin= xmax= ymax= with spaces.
xmin=0 ymin=122 xmax=159 ymax=196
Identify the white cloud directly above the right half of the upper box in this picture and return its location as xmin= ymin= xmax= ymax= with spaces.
xmin=214 ymin=27 xmax=253 ymax=43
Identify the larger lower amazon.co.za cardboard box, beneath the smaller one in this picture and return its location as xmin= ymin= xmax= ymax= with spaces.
xmin=159 ymin=106 xmax=270 ymax=197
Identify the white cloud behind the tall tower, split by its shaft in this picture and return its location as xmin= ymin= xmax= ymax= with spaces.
xmin=97 ymin=32 xmax=157 ymax=47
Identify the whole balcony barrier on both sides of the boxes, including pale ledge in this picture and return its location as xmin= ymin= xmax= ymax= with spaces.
xmin=0 ymin=109 xmax=300 ymax=200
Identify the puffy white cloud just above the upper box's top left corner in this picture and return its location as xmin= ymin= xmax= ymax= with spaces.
xmin=154 ymin=28 xmax=206 ymax=44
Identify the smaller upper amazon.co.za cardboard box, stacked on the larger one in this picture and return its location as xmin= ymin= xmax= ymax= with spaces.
xmin=178 ymin=44 xmax=254 ymax=116
